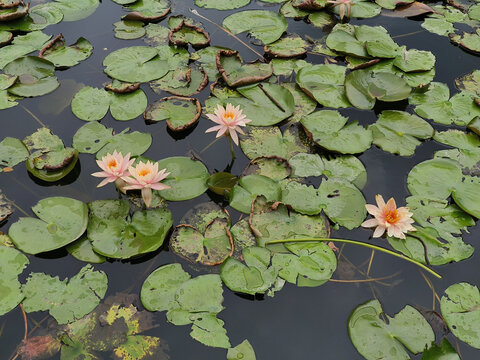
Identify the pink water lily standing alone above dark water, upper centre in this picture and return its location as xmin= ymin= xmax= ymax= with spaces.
xmin=205 ymin=104 xmax=252 ymax=145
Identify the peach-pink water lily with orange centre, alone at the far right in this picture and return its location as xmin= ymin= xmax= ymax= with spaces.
xmin=362 ymin=195 xmax=417 ymax=239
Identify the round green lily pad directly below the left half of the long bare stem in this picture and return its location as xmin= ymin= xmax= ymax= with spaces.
xmin=272 ymin=242 xmax=337 ymax=287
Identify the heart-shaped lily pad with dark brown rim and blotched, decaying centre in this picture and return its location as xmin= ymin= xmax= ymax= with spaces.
xmin=170 ymin=218 xmax=234 ymax=266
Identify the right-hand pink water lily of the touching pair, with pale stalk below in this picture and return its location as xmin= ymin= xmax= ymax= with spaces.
xmin=122 ymin=161 xmax=171 ymax=208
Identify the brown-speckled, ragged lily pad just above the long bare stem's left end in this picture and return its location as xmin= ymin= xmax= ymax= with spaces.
xmin=250 ymin=197 xmax=330 ymax=252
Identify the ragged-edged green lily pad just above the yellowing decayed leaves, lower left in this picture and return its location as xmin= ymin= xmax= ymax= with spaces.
xmin=22 ymin=265 xmax=108 ymax=324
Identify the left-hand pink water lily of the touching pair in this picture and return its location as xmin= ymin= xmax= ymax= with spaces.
xmin=92 ymin=150 xmax=135 ymax=191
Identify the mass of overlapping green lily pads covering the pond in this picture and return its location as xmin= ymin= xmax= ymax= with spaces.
xmin=0 ymin=0 xmax=480 ymax=360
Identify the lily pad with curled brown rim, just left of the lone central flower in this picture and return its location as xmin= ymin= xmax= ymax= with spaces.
xmin=143 ymin=96 xmax=202 ymax=131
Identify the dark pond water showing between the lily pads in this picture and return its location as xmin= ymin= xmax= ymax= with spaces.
xmin=0 ymin=0 xmax=480 ymax=360
